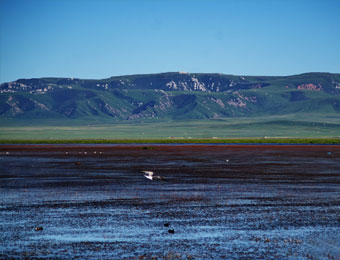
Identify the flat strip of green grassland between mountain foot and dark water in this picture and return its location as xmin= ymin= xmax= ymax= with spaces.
xmin=0 ymin=114 xmax=340 ymax=143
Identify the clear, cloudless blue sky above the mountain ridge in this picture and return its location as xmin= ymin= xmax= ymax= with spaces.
xmin=0 ymin=0 xmax=340 ymax=82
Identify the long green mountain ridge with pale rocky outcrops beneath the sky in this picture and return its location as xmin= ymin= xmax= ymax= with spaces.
xmin=0 ymin=72 xmax=340 ymax=122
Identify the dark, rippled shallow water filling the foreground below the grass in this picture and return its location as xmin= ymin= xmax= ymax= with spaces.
xmin=0 ymin=145 xmax=340 ymax=259
